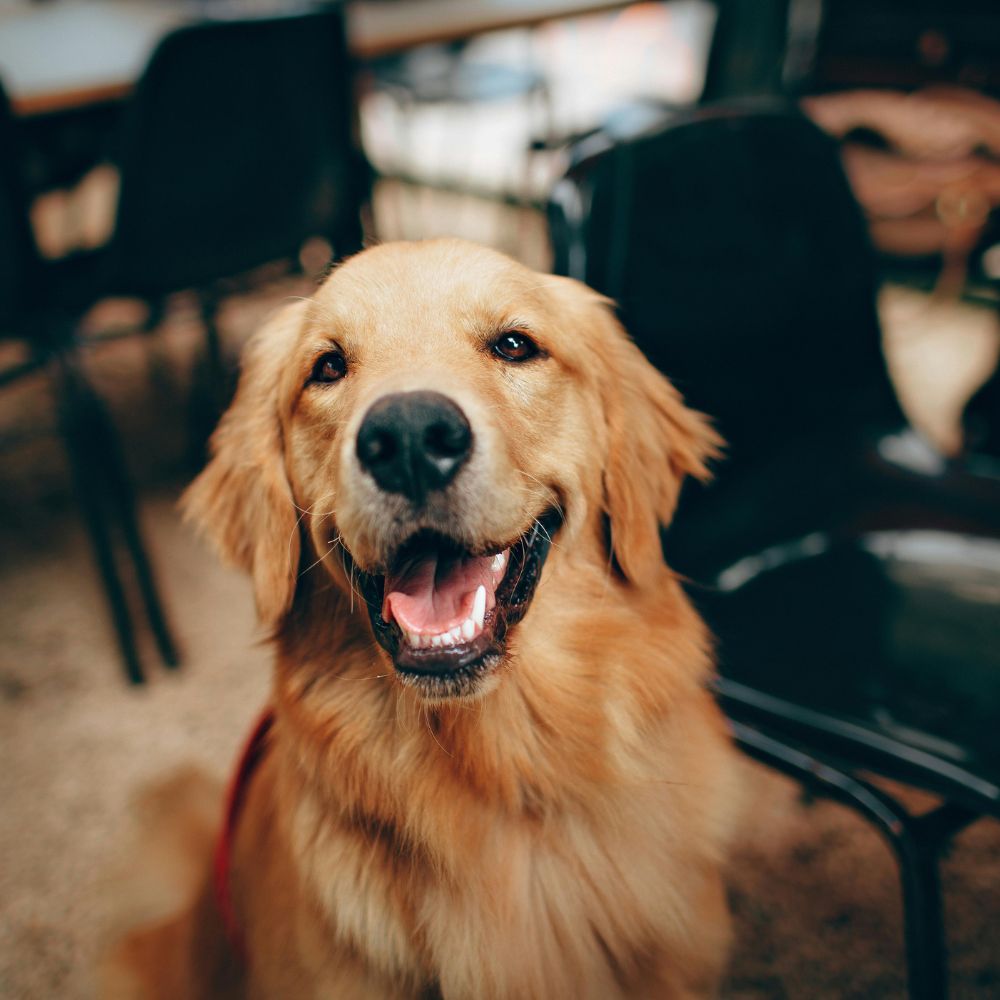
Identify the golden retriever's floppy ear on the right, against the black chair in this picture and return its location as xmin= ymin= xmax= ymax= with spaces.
xmin=574 ymin=283 xmax=723 ymax=585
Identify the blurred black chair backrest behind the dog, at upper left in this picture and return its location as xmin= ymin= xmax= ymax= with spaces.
xmin=111 ymin=6 xmax=367 ymax=294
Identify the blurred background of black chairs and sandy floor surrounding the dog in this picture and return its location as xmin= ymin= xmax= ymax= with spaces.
xmin=0 ymin=0 xmax=1000 ymax=998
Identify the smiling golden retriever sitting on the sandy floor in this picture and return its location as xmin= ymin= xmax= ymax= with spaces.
xmin=113 ymin=240 xmax=738 ymax=1000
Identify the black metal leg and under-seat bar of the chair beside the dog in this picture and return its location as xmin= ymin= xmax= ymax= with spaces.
xmin=731 ymin=722 xmax=979 ymax=1000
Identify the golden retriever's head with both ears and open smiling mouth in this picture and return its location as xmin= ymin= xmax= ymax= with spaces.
xmin=185 ymin=240 xmax=717 ymax=698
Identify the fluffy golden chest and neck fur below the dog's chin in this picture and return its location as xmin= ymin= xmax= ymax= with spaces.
xmin=262 ymin=595 xmax=731 ymax=1000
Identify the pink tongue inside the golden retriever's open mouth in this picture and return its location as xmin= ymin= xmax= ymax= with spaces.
xmin=382 ymin=553 xmax=494 ymax=635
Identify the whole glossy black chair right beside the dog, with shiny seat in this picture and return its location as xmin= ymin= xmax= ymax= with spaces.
xmin=550 ymin=107 xmax=1000 ymax=997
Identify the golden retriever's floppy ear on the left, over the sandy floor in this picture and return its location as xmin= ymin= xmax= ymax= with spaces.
xmin=181 ymin=302 xmax=306 ymax=628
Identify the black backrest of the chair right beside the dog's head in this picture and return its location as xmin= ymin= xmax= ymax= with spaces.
xmin=551 ymin=109 xmax=903 ymax=477
